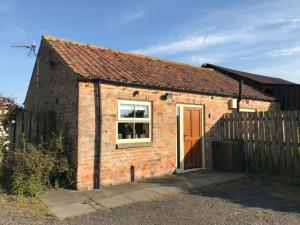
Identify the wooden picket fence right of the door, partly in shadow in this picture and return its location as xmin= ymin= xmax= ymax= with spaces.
xmin=217 ymin=111 xmax=300 ymax=176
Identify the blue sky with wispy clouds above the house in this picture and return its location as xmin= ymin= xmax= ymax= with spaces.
xmin=0 ymin=0 xmax=300 ymax=103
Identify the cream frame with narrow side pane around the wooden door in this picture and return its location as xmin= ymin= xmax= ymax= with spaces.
xmin=176 ymin=104 xmax=205 ymax=173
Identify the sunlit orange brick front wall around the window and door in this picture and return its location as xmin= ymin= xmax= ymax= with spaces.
xmin=77 ymin=82 xmax=279 ymax=189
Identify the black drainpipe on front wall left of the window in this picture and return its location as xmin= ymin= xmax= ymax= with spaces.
xmin=95 ymin=80 xmax=102 ymax=189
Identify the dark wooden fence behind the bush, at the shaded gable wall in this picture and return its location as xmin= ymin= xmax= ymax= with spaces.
xmin=9 ymin=110 xmax=55 ymax=148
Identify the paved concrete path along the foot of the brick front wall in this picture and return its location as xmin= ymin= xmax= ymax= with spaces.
xmin=41 ymin=172 xmax=246 ymax=220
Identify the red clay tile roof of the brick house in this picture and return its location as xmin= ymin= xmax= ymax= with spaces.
xmin=43 ymin=36 xmax=274 ymax=101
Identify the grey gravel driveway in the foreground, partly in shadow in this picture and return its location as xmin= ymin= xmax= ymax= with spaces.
xmin=0 ymin=178 xmax=300 ymax=225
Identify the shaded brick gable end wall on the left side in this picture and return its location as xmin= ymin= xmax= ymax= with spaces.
xmin=24 ymin=41 xmax=78 ymax=172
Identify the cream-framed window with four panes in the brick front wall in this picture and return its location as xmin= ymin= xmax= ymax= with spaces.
xmin=116 ymin=100 xmax=152 ymax=144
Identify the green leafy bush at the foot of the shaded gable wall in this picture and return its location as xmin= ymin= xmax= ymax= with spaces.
xmin=5 ymin=134 xmax=73 ymax=197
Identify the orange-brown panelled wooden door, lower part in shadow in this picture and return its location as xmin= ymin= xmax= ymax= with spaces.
xmin=184 ymin=108 xmax=203 ymax=169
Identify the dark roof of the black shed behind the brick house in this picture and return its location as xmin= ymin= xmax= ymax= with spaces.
xmin=202 ymin=64 xmax=295 ymax=85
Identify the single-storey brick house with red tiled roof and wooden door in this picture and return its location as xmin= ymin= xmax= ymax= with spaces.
xmin=24 ymin=36 xmax=279 ymax=190
